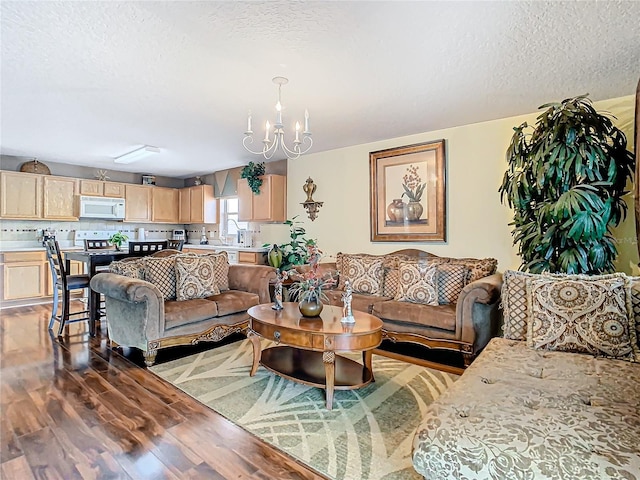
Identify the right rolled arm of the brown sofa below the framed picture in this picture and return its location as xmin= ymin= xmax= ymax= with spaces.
xmin=456 ymin=273 xmax=502 ymax=354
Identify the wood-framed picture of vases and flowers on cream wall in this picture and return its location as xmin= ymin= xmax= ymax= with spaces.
xmin=369 ymin=140 xmax=447 ymax=242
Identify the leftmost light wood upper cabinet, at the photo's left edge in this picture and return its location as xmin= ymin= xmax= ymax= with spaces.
xmin=0 ymin=171 xmax=42 ymax=219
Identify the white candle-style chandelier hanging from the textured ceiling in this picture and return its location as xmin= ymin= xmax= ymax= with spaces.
xmin=242 ymin=77 xmax=313 ymax=160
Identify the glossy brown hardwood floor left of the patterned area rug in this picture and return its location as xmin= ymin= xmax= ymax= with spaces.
xmin=0 ymin=302 xmax=325 ymax=480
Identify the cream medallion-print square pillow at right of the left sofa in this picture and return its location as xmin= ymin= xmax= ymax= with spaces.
xmin=176 ymin=255 xmax=220 ymax=301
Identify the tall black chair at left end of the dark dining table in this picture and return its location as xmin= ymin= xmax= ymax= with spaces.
xmin=45 ymin=240 xmax=89 ymax=336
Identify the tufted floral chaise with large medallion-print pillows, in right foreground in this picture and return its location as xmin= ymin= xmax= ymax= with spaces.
xmin=413 ymin=271 xmax=640 ymax=480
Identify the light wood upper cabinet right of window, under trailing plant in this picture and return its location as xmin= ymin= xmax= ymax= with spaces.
xmin=238 ymin=175 xmax=287 ymax=222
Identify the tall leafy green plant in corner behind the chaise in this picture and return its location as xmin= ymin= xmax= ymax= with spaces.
xmin=499 ymin=95 xmax=635 ymax=274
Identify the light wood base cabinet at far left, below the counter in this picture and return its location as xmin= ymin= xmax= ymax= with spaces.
xmin=0 ymin=251 xmax=50 ymax=300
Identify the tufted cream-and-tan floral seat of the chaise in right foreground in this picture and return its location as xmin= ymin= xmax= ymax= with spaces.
xmin=412 ymin=338 xmax=640 ymax=480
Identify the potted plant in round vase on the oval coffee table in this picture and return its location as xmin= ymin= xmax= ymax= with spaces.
xmin=286 ymin=244 xmax=337 ymax=317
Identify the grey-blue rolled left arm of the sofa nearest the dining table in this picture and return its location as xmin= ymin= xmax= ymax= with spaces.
xmin=90 ymin=273 xmax=164 ymax=344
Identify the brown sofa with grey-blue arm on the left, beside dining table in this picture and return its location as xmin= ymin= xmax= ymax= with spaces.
xmin=91 ymin=252 xmax=275 ymax=366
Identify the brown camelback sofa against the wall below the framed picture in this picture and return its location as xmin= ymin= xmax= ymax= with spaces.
xmin=322 ymin=249 xmax=502 ymax=366
